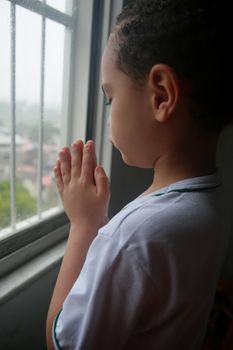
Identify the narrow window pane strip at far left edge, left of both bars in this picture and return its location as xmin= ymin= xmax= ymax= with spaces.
xmin=0 ymin=1 xmax=11 ymax=231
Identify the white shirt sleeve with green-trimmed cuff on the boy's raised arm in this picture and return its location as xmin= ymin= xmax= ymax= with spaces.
xmin=54 ymin=228 xmax=157 ymax=350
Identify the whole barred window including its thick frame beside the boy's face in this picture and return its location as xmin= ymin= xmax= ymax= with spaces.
xmin=0 ymin=0 xmax=121 ymax=274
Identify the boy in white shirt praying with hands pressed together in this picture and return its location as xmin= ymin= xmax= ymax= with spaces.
xmin=47 ymin=0 xmax=232 ymax=350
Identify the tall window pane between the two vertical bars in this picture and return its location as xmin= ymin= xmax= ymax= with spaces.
xmin=15 ymin=6 xmax=41 ymax=221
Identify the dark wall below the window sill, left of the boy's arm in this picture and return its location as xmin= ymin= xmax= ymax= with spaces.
xmin=0 ymin=267 xmax=58 ymax=350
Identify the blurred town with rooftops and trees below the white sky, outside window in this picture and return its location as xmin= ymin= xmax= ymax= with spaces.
xmin=0 ymin=100 xmax=61 ymax=229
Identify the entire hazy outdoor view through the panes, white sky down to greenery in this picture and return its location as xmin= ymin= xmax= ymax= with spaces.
xmin=0 ymin=0 xmax=68 ymax=232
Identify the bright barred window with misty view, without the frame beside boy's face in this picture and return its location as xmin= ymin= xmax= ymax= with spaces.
xmin=0 ymin=0 xmax=75 ymax=278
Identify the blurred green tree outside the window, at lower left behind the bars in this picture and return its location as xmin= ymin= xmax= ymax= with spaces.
xmin=0 ymin=180 xmax=36 ymax=229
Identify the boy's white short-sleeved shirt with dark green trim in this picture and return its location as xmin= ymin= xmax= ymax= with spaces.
xmin=54 ymin=175 xmax=228 ymax=350
